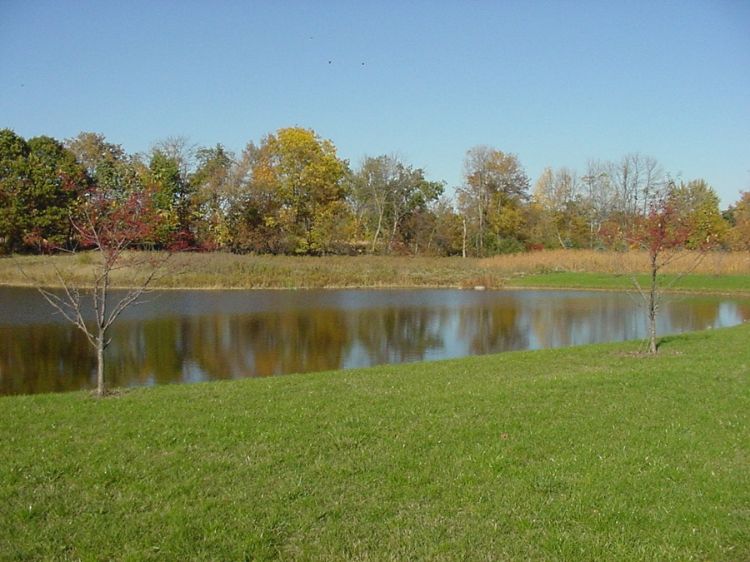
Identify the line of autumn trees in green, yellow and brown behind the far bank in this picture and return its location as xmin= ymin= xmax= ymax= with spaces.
xmin=0 ymin=127 xmax=750 ymax=256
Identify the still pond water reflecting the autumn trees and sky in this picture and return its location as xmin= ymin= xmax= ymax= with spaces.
xmin=0 ymin=287 xmax=750 ymax=394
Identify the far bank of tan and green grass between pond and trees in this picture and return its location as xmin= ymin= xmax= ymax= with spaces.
xmin=0 ymin=250 xmax=750 ymax=294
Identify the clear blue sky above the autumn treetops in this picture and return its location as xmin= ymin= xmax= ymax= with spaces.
xmin=0 ymin=0 xmax=750 ymax=206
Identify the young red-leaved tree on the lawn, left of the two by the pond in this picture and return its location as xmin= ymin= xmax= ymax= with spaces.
xmin=29 ymin=187 xmax=170 ymax=396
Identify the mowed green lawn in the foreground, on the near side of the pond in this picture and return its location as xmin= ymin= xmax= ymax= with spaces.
xmin=0 ymin=324 xmax=750 ymax=561
